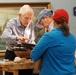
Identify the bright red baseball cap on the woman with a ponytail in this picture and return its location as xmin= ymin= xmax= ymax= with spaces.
xmin=52 ymin=9 xmax=69 ymax=22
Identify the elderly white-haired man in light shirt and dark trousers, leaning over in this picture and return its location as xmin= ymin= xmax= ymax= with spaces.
xmin=1 ymin=5 xmax=35 ymax=75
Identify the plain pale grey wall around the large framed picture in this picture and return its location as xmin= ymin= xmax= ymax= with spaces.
xmin=0 ymin=0 xmax=76 ymax=36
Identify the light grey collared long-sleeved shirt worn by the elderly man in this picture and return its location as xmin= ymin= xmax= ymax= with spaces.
xmin=1 ymin=17 xmax=35 ymax=50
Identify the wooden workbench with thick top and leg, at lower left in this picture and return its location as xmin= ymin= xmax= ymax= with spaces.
xmin=0 ymin=59 xmax=34 ymax=75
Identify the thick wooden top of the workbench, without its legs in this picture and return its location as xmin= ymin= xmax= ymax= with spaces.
xmin=0 ymin=59 xmax=34 ymax=70
